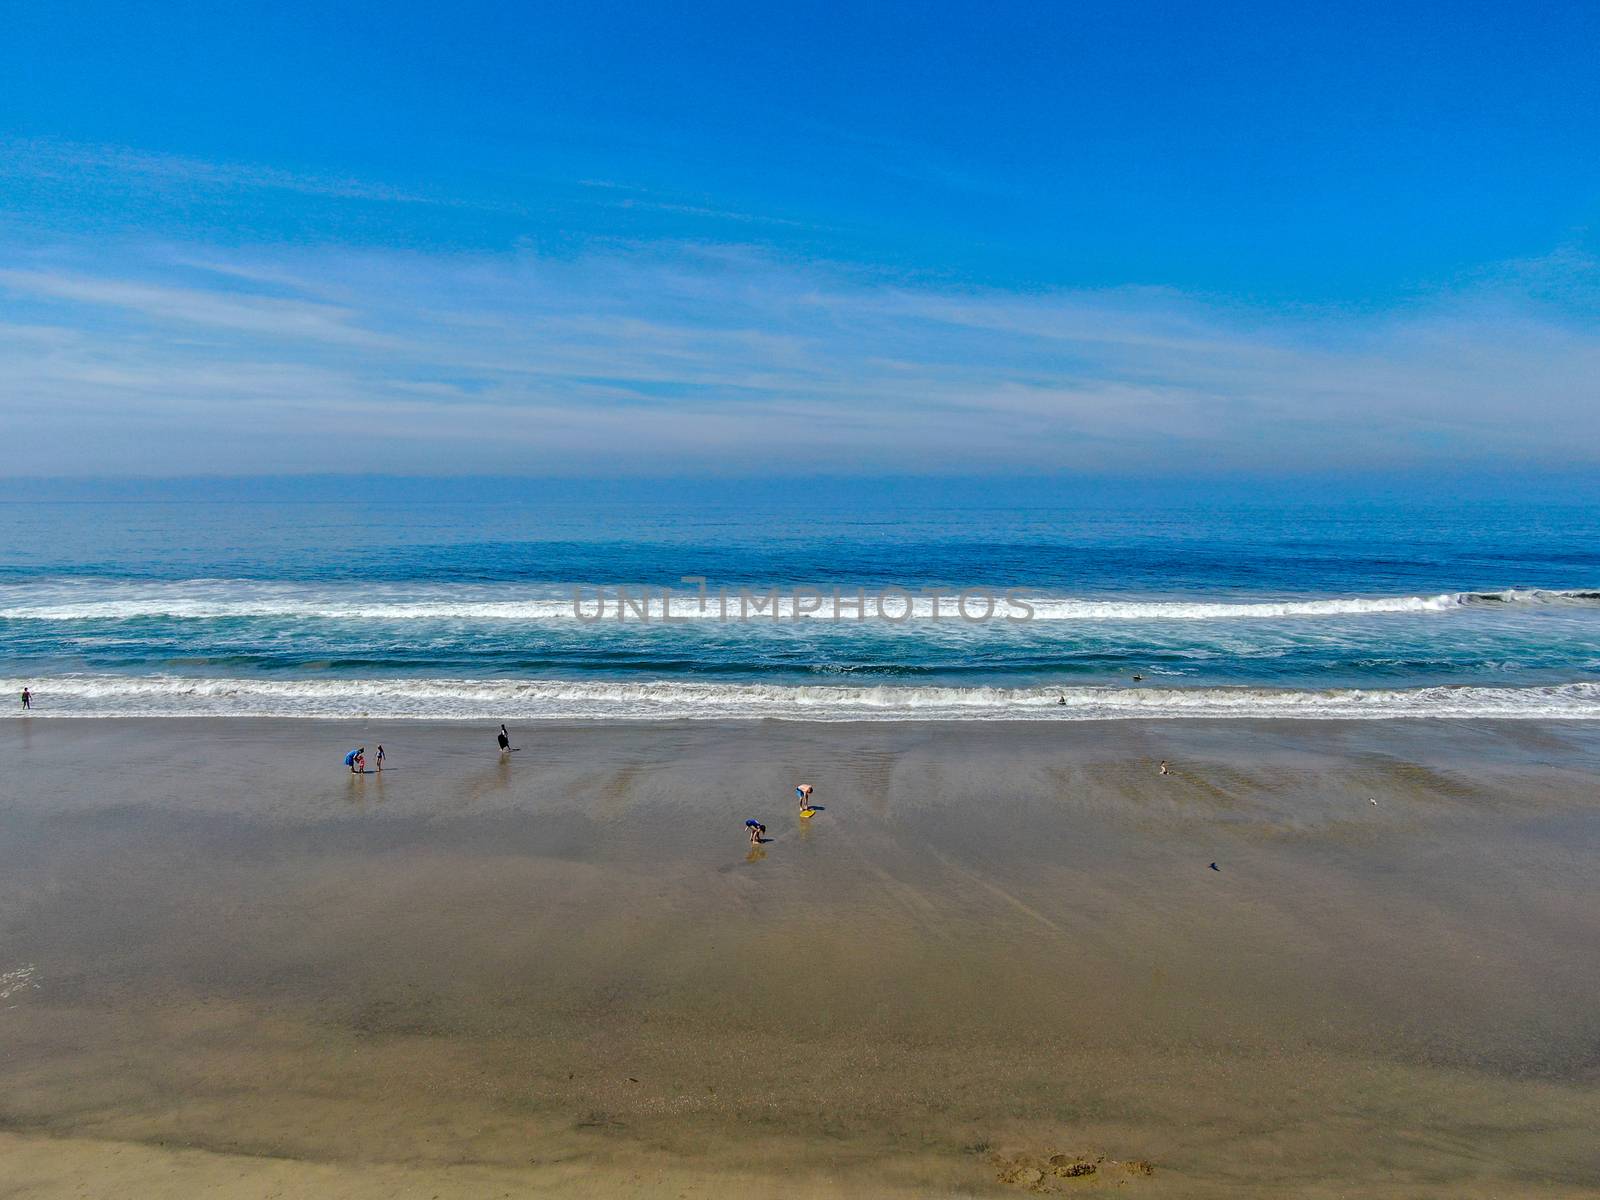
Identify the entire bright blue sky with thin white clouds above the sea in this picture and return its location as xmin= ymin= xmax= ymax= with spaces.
xmin=0 ymin=3 xmax=1600 ymax=475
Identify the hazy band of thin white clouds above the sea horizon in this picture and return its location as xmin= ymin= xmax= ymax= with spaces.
xmin=0 ymin=232 xmax=1600 ymax=475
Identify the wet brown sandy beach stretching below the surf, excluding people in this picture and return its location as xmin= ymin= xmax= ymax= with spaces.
xmin=0 ymin=720 xmax=1600 ymax=1197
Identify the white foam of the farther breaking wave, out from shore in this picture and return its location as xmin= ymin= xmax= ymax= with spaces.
xmin=0 ymin=579 xmax=1600 ymax=624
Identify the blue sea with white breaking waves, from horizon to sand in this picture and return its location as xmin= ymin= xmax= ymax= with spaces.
xmin=0 ymin=488 xmax=1600 ymax=720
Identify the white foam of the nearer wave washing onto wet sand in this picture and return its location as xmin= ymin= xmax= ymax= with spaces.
xmin=9 ymin=675 xmax=1600 ymax=722
